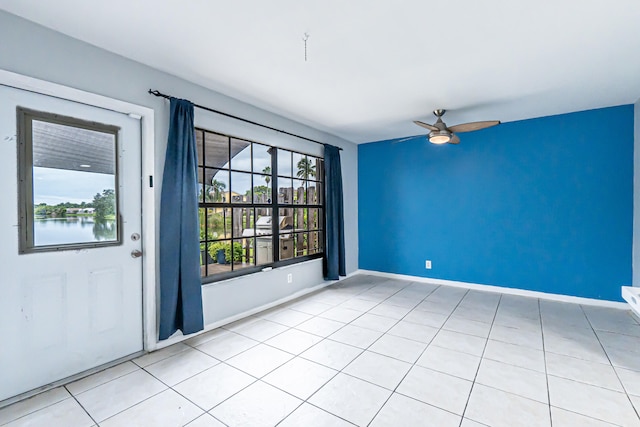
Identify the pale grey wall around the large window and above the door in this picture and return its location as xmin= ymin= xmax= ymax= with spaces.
xmin=0 ymin=11 xmax=358 ymax=338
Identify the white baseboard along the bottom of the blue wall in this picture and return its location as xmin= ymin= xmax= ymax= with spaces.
xmin=357 ymin=270 xmax=628 ymax=310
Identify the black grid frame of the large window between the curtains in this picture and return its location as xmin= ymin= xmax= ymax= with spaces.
xmin=195 ymin=126 xmax=326 ymax=285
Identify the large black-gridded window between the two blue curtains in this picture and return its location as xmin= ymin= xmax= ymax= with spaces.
xmin=196 ymin=129 xmax=324 ymax=282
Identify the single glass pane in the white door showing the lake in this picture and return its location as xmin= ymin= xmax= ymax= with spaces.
xmin=23 ymin=118 xmax=118 ymax=251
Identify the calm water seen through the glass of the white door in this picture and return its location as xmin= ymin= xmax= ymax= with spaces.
xmin=33 ymin=217 xmax=117 ymax=246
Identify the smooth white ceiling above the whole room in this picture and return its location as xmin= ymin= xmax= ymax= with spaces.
xmin=0 ymin=0 xmax=640 ymax=143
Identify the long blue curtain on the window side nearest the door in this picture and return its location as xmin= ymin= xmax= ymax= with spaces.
xmin=159 ymin=98 xmax=204 ymax=340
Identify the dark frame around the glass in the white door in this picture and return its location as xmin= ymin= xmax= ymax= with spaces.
xmin=16 ymin=106 xmax=122 ymax=255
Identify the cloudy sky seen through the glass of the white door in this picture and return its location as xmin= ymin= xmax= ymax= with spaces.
xmin=33 ymin=167 xmax=115 ymax=205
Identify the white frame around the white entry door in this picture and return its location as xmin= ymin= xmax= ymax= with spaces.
xmin=0 ymin=68 xmax=158 ymax=351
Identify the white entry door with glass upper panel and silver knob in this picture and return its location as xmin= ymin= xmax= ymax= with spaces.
xmin=0 ymin=85 xmax=143 ymax=401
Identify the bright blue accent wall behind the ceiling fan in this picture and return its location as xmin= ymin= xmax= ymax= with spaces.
xmin=358 ymin=105 xmax=634 ymax=301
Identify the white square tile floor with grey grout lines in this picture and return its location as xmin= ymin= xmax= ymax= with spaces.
xmin=0 ymin=275 xmax=640 ymax=427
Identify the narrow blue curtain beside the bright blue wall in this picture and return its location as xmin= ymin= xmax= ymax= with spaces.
xmin=323 ymin=144 xmax=346 ymax=280
